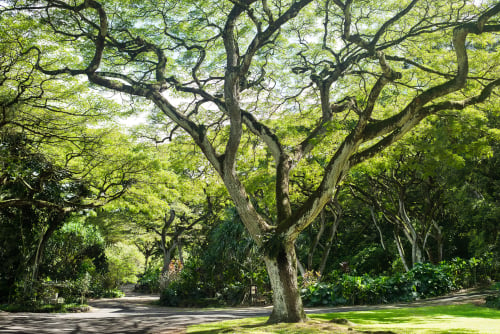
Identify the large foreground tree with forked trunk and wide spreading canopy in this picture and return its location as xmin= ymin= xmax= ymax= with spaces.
xmin=0 ymin=0 xmax=500 ymax=322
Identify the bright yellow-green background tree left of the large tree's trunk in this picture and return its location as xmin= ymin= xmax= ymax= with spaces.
xmin=92 ymin=138 xmax=221 ymax=274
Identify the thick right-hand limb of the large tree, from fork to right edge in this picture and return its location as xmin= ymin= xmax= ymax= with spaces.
xmin=277 ymin=4 xmax=500 ymax=240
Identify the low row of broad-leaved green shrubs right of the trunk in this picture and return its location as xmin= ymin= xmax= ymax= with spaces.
xmin=301 ymin=254 xmax=498 ymax=306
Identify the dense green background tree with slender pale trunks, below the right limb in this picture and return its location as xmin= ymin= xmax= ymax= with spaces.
xmin=350 ymin=102 xmax=498 ymax=269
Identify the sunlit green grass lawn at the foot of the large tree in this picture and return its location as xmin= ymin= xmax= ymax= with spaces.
xmin=187 ymin=304 xmax=500 ymax=334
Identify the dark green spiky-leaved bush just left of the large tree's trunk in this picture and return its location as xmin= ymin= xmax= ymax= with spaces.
xmin=161 ymin=208 xmax=269 ymax=306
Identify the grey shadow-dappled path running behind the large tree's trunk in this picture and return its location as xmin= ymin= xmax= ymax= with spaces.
xmin=0 ymin=291 xmax=488 ymax=334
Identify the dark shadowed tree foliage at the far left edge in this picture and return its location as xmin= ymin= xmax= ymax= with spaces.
xmin=0 ymin=131 xmax=88 ymax=300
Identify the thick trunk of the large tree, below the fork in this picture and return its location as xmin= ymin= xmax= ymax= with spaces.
xmin=264 ymin=243 xmax=306 ymax=323
